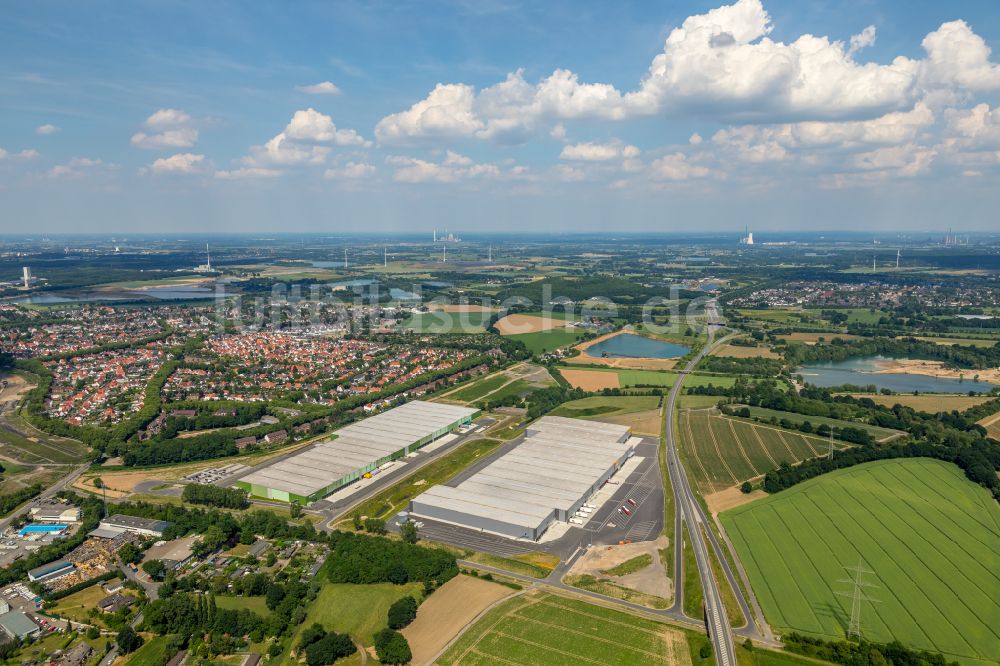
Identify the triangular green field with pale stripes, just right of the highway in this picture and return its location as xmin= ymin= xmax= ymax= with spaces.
xmin=678 ymin=409 xmax=844 ymax=493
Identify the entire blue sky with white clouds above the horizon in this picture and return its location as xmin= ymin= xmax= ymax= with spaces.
xmin=0 ymin=0 xmax=1000 ymax=233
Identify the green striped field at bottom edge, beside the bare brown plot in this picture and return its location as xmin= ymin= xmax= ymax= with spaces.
xmin=436 ymin=592 xmax=688 ymax=666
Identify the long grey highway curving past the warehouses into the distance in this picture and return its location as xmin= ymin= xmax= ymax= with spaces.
xmin=664 ymin=299 xmax=757 ymax=666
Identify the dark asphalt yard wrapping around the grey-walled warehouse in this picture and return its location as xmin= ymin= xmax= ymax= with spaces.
xmin=398 ymin=438 xmax=663 ymax=561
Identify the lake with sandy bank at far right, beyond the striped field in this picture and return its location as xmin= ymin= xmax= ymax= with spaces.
xmin=795 ymin=356 xmax=993 ymax=393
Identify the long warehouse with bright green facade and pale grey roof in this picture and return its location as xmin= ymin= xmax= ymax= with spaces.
xmin=236 ymin=400 xmax=479 ymax=504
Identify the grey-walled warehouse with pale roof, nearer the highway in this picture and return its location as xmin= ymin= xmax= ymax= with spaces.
xmin=410 ymin=416 xmax=633 ymax=540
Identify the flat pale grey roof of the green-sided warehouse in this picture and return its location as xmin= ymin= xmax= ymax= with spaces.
xmin=240 ymin=400 xmax=477 ymax=497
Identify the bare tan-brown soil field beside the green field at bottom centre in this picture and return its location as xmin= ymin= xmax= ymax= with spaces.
xmin=402 ymin=576 xmax=514 ymax=665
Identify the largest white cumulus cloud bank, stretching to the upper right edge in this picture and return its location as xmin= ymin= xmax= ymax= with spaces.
xmin=375 ymin=0 xmax=1000 ymax=144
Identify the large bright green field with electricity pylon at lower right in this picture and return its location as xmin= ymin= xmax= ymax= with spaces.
xmin=722 ymin=458 xmax=1000 ymax=665
